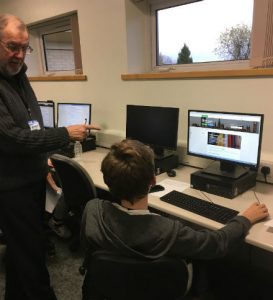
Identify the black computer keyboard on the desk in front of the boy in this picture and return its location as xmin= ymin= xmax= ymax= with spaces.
xmin=160 ymin=191 xmax=239 ymax=224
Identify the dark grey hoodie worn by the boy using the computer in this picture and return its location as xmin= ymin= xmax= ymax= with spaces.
xmin=82 ymin=199 xmax=251 ymax=259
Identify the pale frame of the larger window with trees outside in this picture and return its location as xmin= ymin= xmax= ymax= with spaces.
xmin=149 ymin=0 xmax=252 ymax=72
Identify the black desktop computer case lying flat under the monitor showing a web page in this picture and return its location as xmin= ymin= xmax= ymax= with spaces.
xmin=191 ymin=170 xmax=256 ymax=199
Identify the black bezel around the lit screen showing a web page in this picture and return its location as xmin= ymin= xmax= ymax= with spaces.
xmin=187 ymin=109 xmax=264 ymax=171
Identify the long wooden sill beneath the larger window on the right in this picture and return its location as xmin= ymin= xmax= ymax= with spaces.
xmin=121 ymin=68 xmax=273 ymax=80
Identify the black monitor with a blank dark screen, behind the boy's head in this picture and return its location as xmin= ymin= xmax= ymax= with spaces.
xmin=126 ymin=105 xmax=179 ymax=156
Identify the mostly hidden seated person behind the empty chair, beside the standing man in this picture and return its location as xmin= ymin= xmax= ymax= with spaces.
xmin=47 ymin=159 xmax=71 ymax=239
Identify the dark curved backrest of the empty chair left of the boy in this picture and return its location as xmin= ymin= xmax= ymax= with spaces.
xmin=50 ymin=154 xmax=97 ymax=212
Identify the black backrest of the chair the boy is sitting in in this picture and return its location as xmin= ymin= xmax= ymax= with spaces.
xmin=83 ymin=251 xmax=189 ymax=300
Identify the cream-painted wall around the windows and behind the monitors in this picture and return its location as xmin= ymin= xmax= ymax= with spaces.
xmin=0 ymin=0 xmax=273 ymax=161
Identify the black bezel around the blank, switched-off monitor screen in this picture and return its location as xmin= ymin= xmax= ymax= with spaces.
xmin=126 ymin=104 xmax=180 ymax=156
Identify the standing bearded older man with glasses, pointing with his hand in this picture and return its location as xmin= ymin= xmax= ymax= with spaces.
xmin=0 ymin=14 xmax=97 ymax=300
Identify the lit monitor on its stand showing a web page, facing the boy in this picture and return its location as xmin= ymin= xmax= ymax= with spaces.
xmin=187 ymin=110 xmax=264 ymax=178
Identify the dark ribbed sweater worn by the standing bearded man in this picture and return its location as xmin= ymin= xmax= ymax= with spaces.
xmin=0 ymin=66 xmax=69 ymax=191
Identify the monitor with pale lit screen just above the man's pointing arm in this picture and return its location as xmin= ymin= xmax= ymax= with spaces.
xmin=57 ymin=103 xmax=91 ymax=127
